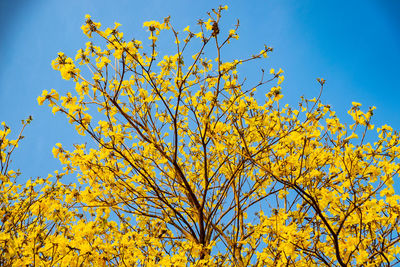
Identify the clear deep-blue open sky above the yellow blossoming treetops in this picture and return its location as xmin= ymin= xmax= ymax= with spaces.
xmin=0 ymin=0 xmax=400 ymax=180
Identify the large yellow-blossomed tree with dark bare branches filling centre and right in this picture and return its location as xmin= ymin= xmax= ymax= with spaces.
xmin=0 ymin=7 xmax=400 ymax=266
